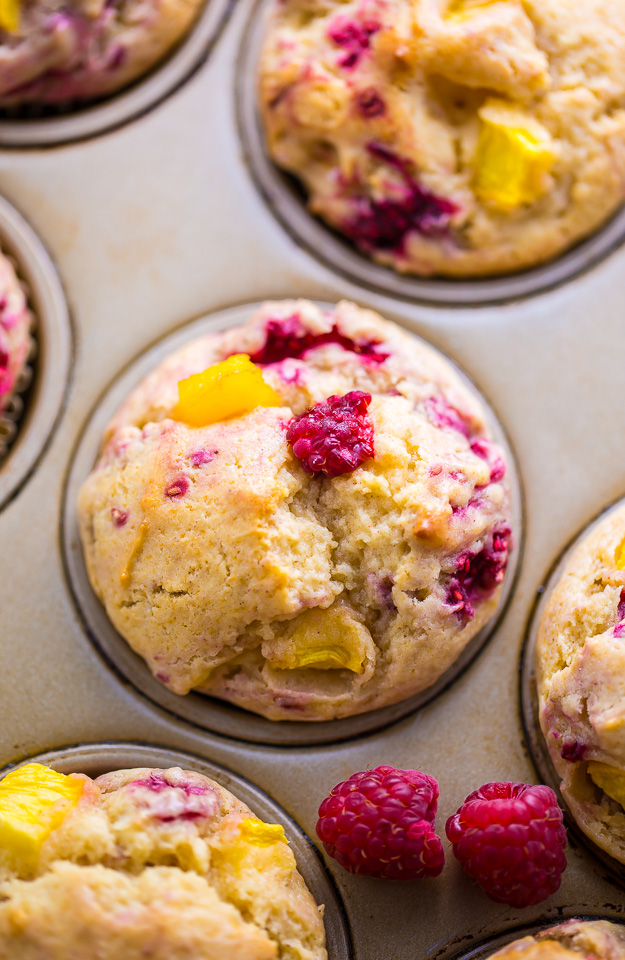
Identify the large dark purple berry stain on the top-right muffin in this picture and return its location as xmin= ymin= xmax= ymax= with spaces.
xmin=342 ymin=143 xmax=458 ymax=255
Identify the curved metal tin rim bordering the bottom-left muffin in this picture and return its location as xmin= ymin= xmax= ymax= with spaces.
xmin=0 ymin=740 xmax=354 ymax=960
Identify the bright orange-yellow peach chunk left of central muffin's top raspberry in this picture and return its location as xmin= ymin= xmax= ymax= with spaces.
xmin=172 ymin=353 xmax=282 ymax=427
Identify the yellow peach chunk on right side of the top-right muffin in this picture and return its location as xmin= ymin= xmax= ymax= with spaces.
xmin=473 ymin=100 xmax=556 ymax=211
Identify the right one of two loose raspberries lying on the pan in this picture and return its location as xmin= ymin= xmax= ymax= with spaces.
xmin=445 ymin=783 xmax=566 ymax=907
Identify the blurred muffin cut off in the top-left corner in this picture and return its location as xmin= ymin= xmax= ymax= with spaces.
xmin=0 ymin=0 xmax=202 ymax=107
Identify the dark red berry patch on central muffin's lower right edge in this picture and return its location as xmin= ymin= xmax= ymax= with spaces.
xmin=445 ymin=527 xmax=510 ymax=623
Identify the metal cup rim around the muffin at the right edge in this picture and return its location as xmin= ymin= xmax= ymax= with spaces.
xmin=519 ymin=500 xmax=625 ymax=887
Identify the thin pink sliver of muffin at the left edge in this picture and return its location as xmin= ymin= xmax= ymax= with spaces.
xmin=0 ymin=251 xmax=32 ymax=419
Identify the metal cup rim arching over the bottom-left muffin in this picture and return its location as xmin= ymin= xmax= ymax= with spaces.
xmin=0 ymin=742 xmax=353 ymax=960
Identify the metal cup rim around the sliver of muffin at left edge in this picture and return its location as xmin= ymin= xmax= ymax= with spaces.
xmin=0 ymin=195 xmax=75 ymax=511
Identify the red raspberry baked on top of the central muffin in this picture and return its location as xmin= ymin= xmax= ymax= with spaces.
xmin=286 ymin=390 xmax=374 ymax=477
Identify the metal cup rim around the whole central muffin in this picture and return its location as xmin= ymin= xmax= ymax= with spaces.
xmin=61 ymin=303 xmax=523 ymax=746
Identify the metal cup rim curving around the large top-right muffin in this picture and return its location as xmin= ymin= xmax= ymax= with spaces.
xmin=234 ymin=0 xmax=625 ymax=310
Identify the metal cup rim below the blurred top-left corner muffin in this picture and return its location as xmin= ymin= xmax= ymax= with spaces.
xmin=0 ymin=0 xmax=235 ymax=151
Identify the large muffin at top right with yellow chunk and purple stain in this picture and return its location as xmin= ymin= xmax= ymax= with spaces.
xmin=259 ymin=0 xmax=625 ymax=277
